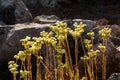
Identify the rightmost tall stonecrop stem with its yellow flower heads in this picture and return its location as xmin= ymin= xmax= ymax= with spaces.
xmin=98 ymin=28 xmax=111 ymax=80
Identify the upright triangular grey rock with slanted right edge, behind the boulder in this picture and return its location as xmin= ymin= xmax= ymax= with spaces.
xmin=15 ymin=0 xmax=32 ymax=23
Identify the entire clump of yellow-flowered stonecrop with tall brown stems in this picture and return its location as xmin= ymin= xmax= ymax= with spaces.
xmin=8 ymin=21 xmax=111 ymax=80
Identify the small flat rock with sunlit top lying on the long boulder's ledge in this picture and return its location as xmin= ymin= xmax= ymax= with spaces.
xmin=33 ymin=15 xmax=60 ymax=24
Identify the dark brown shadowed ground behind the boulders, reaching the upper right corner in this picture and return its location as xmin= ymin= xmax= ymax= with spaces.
xmin=36 ymin=0 xmax=120 ymax=24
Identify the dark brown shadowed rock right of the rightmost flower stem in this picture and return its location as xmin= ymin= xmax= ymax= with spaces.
xmin=106 ymin=41 xmax=120 ymax=77
